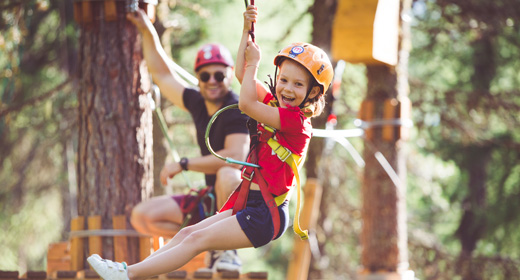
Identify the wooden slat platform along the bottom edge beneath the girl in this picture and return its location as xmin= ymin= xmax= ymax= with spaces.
xmin=0 ymin=270 xmax=268 ymax=280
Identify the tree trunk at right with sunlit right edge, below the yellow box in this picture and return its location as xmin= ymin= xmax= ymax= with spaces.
xmin=361 ymin=0 xmax=411 ymax=273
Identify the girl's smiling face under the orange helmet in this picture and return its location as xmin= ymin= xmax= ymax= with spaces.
xmin=276 ymin=59 xmax=319 ymax=108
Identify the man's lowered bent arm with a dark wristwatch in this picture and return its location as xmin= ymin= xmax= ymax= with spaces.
xmin=160 ymin=133 xmax=249 ymax=185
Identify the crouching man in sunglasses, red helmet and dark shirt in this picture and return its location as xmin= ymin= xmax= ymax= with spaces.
xmin=127 ymin=10 xmax=249 ymax=270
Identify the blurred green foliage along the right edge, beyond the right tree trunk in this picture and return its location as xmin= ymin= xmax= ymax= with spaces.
xmin=409 ymin=1 xmax=520 ymax=279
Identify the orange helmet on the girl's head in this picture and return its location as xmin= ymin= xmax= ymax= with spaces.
xmin=274 ymin=43 xmax=334 ymax=93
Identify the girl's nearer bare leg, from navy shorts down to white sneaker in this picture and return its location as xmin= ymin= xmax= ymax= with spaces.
xmin=128 ymin=211 xmax=253 ymax=280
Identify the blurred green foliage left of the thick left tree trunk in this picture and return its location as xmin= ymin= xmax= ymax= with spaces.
xmin=0 ymin=1 xmax=76 ymax=272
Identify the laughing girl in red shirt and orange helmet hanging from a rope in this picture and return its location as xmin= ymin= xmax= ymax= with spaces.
xmin=88 ymin=5 xmax=333 ymax=280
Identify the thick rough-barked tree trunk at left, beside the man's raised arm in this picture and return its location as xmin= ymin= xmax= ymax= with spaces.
xmin=77 ymin=1 xmax=153 ymax=264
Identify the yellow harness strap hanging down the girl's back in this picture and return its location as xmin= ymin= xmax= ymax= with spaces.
xmin=264 ymin=125 xmax=309 ymax=240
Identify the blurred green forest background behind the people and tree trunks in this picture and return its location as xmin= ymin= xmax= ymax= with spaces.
xmin=0 ymin=0 xmax=520 ymax=279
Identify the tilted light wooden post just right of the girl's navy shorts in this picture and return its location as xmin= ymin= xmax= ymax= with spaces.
xmin=286 ymin=178 xmax=322 ymax=280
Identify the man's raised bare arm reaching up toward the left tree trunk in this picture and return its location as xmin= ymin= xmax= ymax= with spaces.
xmin=126 ymin=10 xmax=188 ymax=110
